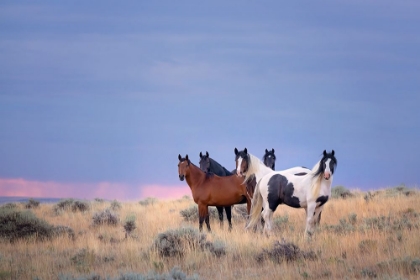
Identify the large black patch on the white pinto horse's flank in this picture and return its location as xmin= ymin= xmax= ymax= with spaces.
xmin=267 ymin=174 xmax=301 ymax=212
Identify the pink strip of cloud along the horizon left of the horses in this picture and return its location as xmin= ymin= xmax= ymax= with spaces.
xmin=0 ymin=178 xmax=191 ymax=201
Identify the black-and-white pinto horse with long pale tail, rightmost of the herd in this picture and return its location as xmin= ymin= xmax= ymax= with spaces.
xmin=246 ymin=150 xmax=337 ymax=237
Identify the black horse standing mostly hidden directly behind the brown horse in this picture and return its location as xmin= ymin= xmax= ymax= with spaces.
xmin=200 ymin=151 xmax=232 ymax=231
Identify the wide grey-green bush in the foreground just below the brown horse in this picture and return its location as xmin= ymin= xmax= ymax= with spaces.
xmin=153 ymin=227 xmax=226 ymax=257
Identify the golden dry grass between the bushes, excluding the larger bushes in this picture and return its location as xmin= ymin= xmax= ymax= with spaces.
xmin=0 ymin=189 xmax=420 ymax=279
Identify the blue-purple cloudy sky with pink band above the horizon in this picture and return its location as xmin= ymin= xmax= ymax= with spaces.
xmin=0 ymin=0 xmax=420 ymax=201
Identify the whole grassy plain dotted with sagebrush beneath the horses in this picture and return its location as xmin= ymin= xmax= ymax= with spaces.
xmin=0 ymin=186 xmax=420 ymax=280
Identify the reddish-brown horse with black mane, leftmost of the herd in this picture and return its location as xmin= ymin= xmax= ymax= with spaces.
xmin=178 ymin=155 xmax=251 ymax=231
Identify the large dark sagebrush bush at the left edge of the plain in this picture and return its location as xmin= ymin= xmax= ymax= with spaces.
xmin=0 ymin=208 xmax=54 ymax=241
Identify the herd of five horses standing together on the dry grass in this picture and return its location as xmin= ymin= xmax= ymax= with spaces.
xmin=178 ymin=148 xmax=337 ymax=236
